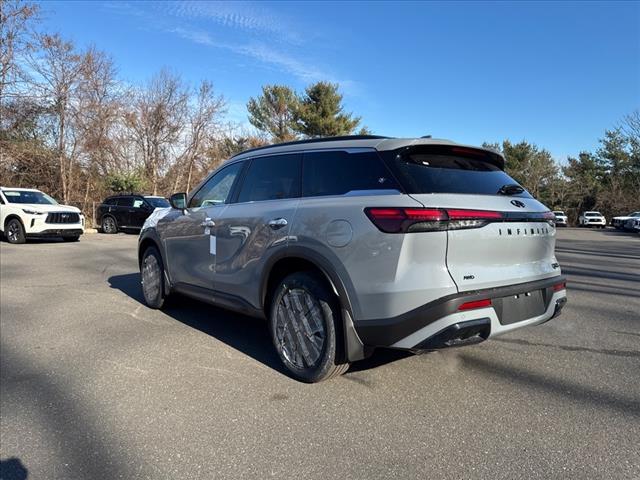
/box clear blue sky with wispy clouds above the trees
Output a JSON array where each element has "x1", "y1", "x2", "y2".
[{"x1": 41, "y1": 1, "x2": 640, "y2": 160}]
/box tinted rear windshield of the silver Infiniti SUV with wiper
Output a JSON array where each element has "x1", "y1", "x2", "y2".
[{"x1": 384, "y1": 145, "x2": 531, "y2": 198}]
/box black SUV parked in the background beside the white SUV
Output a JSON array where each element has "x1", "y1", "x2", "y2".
[{"x1": 96, "y1": 194, "x2": 170, "y2": 233}]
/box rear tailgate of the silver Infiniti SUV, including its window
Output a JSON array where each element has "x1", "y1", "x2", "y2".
[{"x1": 383, "y1": 144, "x2": 560, "y2": 292}]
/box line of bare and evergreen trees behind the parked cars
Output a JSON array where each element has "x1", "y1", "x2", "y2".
[{"x1": 0, "y1": 0, "x2": 640, "y2": 225}]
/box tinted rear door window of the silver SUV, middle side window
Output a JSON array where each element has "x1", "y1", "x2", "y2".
[{"x1": 238, "y1": 154, "x2": 301, "y2": 202}]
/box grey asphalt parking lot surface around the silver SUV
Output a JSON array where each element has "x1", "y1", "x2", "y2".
[{"x1": 0, "y1": 229, "x2": 640, "y2": 480}]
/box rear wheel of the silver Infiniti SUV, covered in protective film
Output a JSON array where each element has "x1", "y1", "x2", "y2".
[{"x1": 269, "y1": 272, "x2": 349, "y2": 383}]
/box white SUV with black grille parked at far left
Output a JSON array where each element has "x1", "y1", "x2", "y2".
[{"x1": 0, "y1": 187, "x2": 84, "y2": 243}]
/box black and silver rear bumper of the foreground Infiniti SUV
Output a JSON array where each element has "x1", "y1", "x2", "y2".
[{"x1": 354, "y1": 275, "x2": 567, "y2": 350}]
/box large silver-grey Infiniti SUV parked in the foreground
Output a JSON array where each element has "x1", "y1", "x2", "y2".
[{"x1": 138, "y1": 136, "x2": 566, "y2": 382}]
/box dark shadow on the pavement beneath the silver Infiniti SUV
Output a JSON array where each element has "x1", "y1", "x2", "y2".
[{"x1": 108, "y1": 273, "x2": 404, "y2": 376}]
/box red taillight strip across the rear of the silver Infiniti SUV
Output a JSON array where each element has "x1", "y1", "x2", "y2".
[{"x1": 364, "y1": 207, "x2": 504, "y2": 233}]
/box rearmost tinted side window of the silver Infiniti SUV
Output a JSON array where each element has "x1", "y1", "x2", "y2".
[{"x1": 302, "y1": 151, "x2": 399, "y2": 197}]
